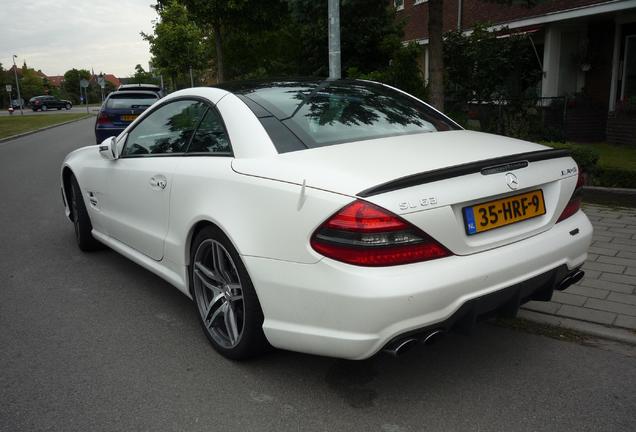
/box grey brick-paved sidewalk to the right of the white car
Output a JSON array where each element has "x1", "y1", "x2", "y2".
[{"x1": 523, "y1": 204, "x2": 636, "y2": 330}]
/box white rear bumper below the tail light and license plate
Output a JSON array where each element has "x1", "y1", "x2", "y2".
[{"x1": 244, "y1": 212, "x2": 592, "y2": 359}]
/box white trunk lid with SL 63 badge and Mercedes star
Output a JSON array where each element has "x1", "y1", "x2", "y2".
[{"x1": 232, "y1": 130, "x2": 576, "y2": 254}]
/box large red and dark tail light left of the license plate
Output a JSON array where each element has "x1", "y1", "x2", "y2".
[{"x1": 311, "y1": 200, "x2": 452, "y2": 267}]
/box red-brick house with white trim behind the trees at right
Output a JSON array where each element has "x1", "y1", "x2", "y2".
[{"x1": 392, "y1": 0, "x2": 636, "y2": 144}]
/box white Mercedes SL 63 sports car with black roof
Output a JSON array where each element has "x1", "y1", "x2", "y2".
[{"x1": 61, "y1": 80, "x2": 592, "y2": 359}]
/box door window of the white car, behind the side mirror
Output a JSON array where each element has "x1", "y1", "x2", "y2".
[{"x1": 122, "y1": 100, "x2": 206, "y2": 157}]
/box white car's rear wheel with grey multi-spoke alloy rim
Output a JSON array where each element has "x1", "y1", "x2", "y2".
[{"x1": 188, "y1": 226, "x2": 269, "y2": 360}]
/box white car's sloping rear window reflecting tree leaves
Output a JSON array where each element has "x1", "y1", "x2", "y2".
[{"x1": 237, "y1": 81, "x2": 458, "y2": 153}]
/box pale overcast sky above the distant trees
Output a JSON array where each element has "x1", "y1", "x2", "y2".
[{"x1": 0, "y1": 0, "x2": 157, "y2": 77}]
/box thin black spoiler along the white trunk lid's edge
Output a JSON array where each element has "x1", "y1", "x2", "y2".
[{"x1": 357, "y1": 149, "x2": 570, "y2": 198}]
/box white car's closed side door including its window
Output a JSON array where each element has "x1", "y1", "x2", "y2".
[{"x1": 101, "y1": 99, "x2": 207, "y2": 260}]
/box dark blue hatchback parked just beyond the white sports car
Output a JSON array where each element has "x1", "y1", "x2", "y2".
[{"x1": 95, "y1": 91, "x2": 159, "y2": 144}]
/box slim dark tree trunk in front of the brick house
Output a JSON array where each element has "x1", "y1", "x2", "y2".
[{"x1": 428, "y1": 0, "x2": 444, "y2": 111}]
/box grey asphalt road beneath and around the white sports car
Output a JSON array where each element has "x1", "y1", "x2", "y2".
[{"x1": 0, "y1": 119, "x2": 636, "y2": 432}]
